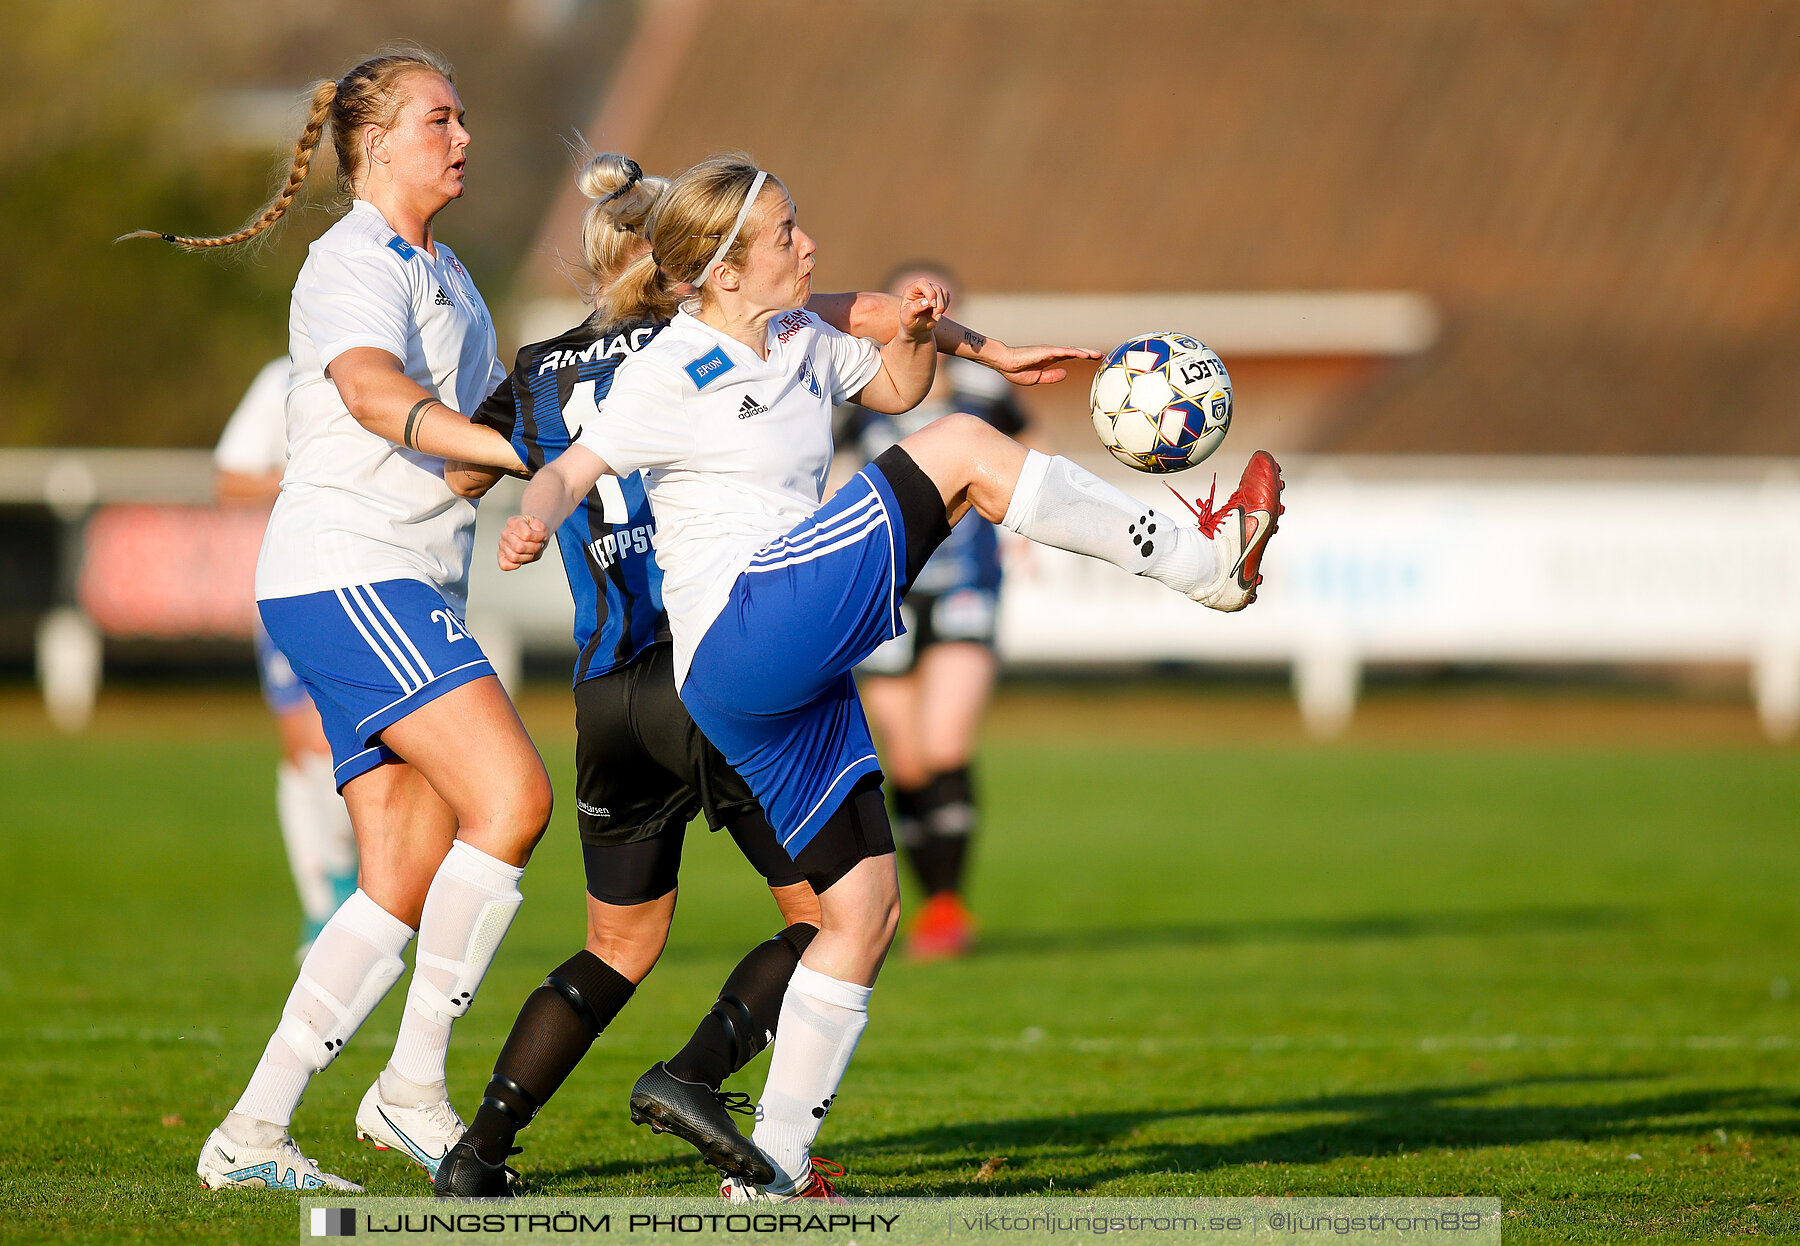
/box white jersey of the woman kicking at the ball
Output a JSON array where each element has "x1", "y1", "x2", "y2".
[{"x1": 571, "y1": 312, "x2": 880, "y2": 684}]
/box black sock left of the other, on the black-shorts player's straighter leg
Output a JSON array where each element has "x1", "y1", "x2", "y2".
[{"x1": 463, "y1": 947, "x2": 637, "y2": 1163}]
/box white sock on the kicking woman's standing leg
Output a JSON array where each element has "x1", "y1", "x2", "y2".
[{"x1": 752, "y1": 965, "x2": 873, "y2": 1185}]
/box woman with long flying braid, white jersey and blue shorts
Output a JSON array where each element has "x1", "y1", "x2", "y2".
[{"x1": 126, "y1": 50, "x2": 551, "y2": 1192}]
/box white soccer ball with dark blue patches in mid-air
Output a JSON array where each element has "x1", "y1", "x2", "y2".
[{"x1": 1089, "y1": 333, "x2": 1231, "y2": 472}]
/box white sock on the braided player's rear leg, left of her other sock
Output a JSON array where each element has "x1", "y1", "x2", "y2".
[{"x1": 227, "y1": 891, "x2": 412, "y2": 1145}]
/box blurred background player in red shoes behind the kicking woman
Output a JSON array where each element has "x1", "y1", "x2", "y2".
[{"x1": 837, "y1": 263, "x2": 1026, "y2": 960}]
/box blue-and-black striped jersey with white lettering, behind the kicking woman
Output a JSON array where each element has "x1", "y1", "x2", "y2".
[{"x1": 472, "y1": 313, "x2": 670, "y2": 684}]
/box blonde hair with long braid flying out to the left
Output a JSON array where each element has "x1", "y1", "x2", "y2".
[{"x1": 113, "y1": 47, "x2": 455, "y2": 250}]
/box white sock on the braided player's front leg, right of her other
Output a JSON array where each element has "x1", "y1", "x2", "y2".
[{"x1": 389, "y1": 839, "x2": 526, "y2": 1106}]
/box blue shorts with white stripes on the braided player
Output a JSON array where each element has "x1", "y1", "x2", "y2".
[{"x1": 257, "y1": 580, "x2": 493, "y2": 789}]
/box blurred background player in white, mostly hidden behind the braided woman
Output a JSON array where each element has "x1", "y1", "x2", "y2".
[{"x1": 212, "y1": 355, "x2": 356, "y2": 960}]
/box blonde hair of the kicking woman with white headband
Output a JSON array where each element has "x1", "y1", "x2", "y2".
[{"x1": 599, "y1": 153, "x2": 785, "y2": 322}]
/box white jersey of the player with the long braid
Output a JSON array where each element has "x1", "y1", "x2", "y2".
[{"x1": 256, "y1": 200, "x2": 506, "y2": 612}]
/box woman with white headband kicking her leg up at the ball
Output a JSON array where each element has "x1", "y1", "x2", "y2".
[{"x1": 500, "y1": 157, "x2": 1282, "y2": 1201}]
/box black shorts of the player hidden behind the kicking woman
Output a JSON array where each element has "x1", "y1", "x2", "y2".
[{"x1": 574, "y1": 641, "x2": 803, "y2": 904}]
